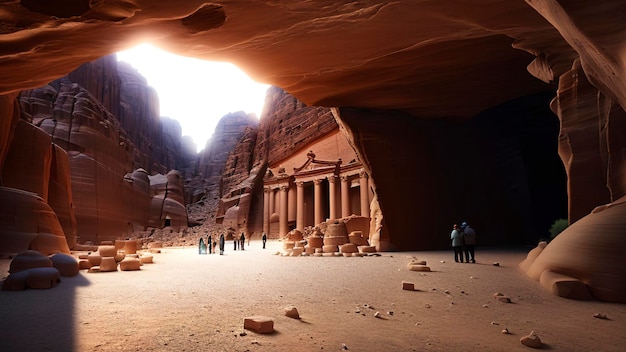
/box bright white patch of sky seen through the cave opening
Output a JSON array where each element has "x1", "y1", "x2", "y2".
[{"x1": 117, "y1": 44, "x2": 269, "y2": 151}]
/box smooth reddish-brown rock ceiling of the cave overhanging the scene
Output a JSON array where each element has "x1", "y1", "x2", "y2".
[{"x1": 0, "y1": 0, "x2": 626, "y2": 118}]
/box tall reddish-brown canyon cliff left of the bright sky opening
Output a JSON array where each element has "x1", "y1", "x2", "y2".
[{"x1": 2, "y1": 55, "x2": 187, "y2": 249}]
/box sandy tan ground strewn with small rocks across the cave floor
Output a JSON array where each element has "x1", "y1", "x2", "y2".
[{"x1": 0, "y1": 241, "x2": 626, "y2": 351}]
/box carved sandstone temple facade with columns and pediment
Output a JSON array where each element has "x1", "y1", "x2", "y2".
[{"x1": 263, "y1": 130, "x2": 373, "y2": 238}]
